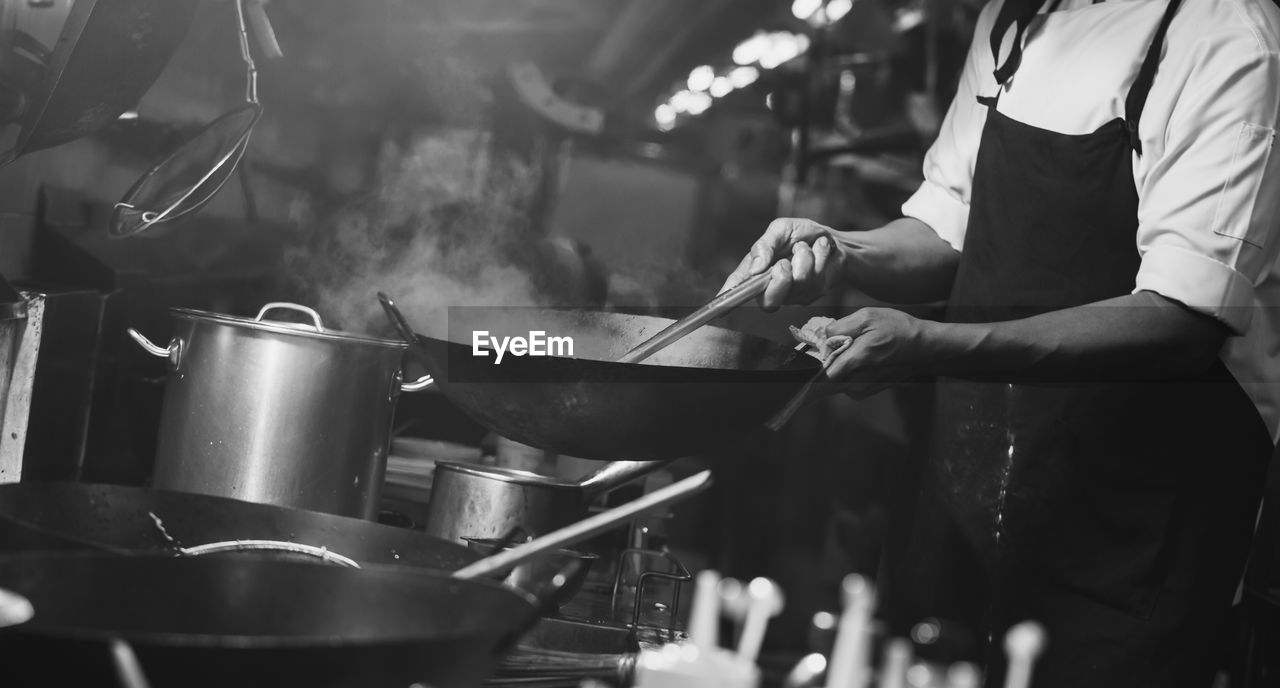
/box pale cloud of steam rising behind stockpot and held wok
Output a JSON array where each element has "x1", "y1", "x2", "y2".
[{"x1": 285, "y1": 125, "x2": 728, "y2": 338}]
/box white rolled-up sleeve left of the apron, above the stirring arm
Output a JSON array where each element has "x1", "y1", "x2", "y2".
[{"x1": 902, "y1": 1, "x2": 1001, "y2": 251}]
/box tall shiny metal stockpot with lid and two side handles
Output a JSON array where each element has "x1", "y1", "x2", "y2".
[{"x1": 129, "y1": 303, "x2": 430, "y2": 519}]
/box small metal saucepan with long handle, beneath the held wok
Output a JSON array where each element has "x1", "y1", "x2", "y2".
[{"x1": 425, "y1": 462, "x2": 671, "y2": 542}]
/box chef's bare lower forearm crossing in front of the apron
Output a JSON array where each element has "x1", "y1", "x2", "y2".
[{"x1": 922, "y1": 286, "x2": 1230, "y2": 381}]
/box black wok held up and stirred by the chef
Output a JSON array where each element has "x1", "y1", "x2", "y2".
[{"x1": 419, "y1": 308, "x2": 818, "y2": 460}]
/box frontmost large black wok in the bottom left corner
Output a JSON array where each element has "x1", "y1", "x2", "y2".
[{"x1": 0, "y1": 552, "x2": 538, "y2": 688}]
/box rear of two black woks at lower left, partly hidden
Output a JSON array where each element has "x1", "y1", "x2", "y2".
[{"x1": 0, "y1": 482, "x2": 480, "y2": 570}]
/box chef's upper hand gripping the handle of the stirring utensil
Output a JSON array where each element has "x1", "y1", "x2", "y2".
[{"x1": 721, "y1": 217, "x2": 845, "y2": 311}]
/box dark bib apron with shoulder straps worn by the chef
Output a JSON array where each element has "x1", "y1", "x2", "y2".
[{"x1": 908, "y1": 0, "x2": 1272, "y2": 688}]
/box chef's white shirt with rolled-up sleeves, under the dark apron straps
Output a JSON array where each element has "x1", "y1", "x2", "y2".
[{"x1": 902, "y1": 0, "x2": 1280, "y2": 439}]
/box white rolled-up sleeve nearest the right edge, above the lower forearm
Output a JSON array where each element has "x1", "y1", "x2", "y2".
[{"x1": 1134, "y1": 32, "x2": 1280, "y2": 334}]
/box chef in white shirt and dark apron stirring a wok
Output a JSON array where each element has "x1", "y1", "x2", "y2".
[{"x1": 726, "y1": 0, "x2": 1280, "y2": 688}]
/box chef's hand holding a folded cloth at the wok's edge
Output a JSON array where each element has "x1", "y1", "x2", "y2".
[{"x1": 824, "y1": 308, "x2": 931, "y2": 398}]
